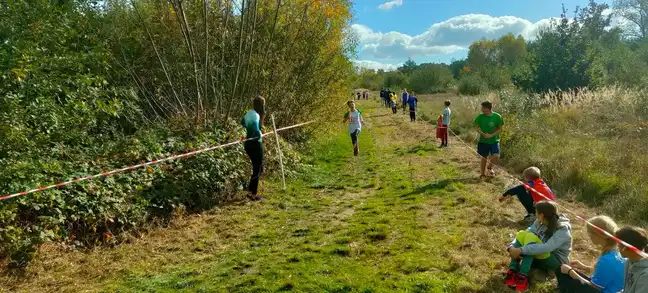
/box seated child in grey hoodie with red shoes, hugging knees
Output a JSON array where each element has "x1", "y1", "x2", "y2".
[{"x1": 505, "y1": 201, "x2": 572, "y2": 292}]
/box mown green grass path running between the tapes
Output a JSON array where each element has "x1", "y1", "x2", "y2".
[{"x1": 0, "y1": 97, "x2": 596, "y2": 292}]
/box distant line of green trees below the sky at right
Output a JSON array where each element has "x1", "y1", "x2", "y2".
[{"x1": 355, "y1": 0, "x2": 648, "y2": 95}]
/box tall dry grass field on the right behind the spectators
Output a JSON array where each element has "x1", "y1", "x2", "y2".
[{"x1": 421, "y1": 88, "x2": 648, "y2": 225}]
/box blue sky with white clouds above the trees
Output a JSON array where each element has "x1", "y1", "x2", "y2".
[{"x1": 352, "y1": 0, "x2": 612, "y2": 69}]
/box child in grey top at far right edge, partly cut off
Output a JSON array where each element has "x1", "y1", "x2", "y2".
[{"x1": 615, "y1": 227, "x2": 648, "y2": 293}]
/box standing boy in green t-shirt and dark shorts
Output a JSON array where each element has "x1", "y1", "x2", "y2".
[{"x1": 474, "y1": 101, "x2": 504, "y2": 178}]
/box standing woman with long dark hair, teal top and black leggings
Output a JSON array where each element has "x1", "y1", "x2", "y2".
[{"x1": 241, "y1": 96, "x2": 265, "y2": 201}]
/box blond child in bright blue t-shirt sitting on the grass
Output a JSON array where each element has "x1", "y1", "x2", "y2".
[{"x1": 560, "y1": 216, "x2": 626, "y2": 293}]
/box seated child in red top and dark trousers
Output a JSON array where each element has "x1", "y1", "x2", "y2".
[{"x1": 499, "y1": 167, "x2": 554, "y2": 223}]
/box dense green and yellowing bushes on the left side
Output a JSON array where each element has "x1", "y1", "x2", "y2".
[{"x1": 0, "y1": 0, "x2": 353, "y2": 265}]
